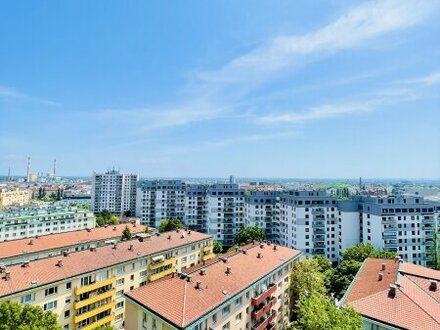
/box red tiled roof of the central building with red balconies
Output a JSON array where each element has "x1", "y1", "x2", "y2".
[{"x1": 127, "y1": 245, "x2": 301, "y2": 327}]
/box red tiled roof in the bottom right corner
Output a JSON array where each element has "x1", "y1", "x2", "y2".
[{"x1": 343, "y1": 258, "x2": 440, "y2": 330}]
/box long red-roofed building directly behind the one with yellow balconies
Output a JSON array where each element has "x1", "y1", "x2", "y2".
[{"x1": 0, "y1": 224, "x2": 146, "y2": 266}]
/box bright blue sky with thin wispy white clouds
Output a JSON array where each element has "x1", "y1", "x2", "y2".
[{"x1": 0, "y1": 0, "x2": 440, "y2": 178}]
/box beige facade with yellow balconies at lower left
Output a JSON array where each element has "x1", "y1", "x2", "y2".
[{"x1": 0, "y1": 232, "x2": 213, "y2": 330}]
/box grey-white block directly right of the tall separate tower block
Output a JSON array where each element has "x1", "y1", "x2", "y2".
[{"x1": 136, "y1": 180, "x2": 186, "y2": 227}]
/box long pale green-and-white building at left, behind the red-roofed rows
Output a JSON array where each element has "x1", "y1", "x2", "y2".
[{"x1": 0, "y1": 206, "x2": 96, "y2": 242}]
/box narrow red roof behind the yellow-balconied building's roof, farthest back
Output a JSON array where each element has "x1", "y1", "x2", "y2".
[{"x1": 0, "y1": 224, "x2": 146, "y2": 261}]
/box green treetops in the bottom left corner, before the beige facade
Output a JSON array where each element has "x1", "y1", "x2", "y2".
[{"x1": 0, "y1": 302, "x2": 61, "y2": 330}]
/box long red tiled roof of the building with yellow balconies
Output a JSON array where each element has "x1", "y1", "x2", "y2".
[{"x1": 0, "y1": 231, "x2": 211, "y2": 298}]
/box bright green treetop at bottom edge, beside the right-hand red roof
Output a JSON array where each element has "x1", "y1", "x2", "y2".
[{"x1": 290, "y1": 292, "x2": 362, "y2": 330}]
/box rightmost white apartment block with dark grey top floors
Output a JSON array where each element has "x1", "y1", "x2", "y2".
[{"x1": 360, "y1": 196, "x2": 440, "y2": 266}]
